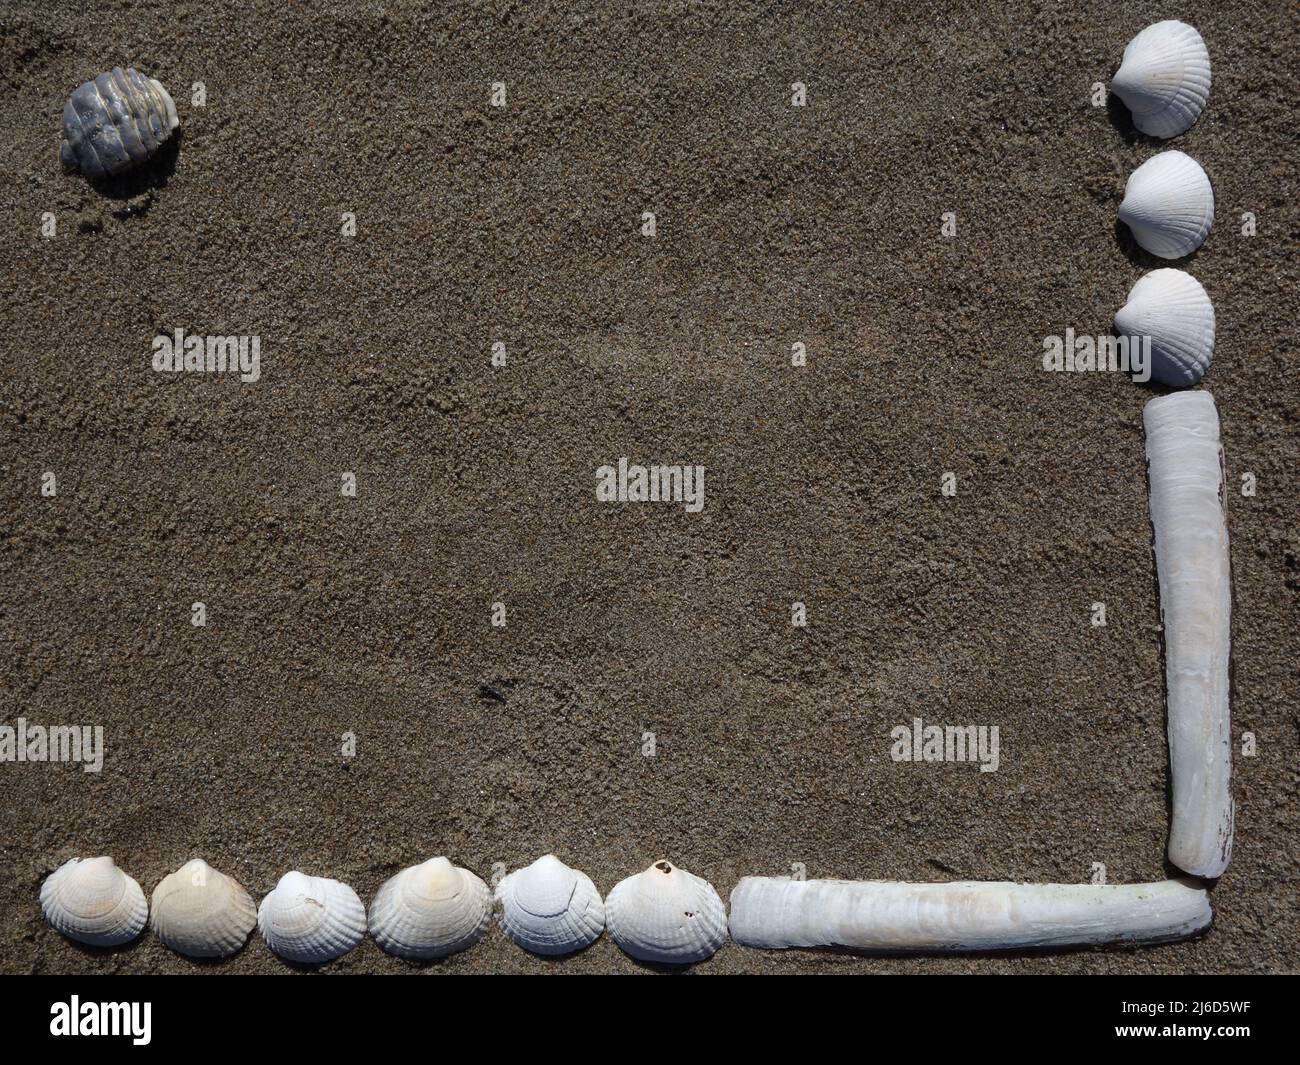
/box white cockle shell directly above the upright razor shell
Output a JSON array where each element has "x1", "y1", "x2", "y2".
[{"x1": 1115, "y1": 269, "x2": 1214, "y2": 386}]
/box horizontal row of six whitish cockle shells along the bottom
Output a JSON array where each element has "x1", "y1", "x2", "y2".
[{"x1": 40, "y1": 854, "x2": 727, "y2": 965}]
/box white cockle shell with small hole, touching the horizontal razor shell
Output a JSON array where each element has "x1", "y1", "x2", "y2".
[{"x1": 605, "y1": 861, "x2": 727, "y2": 965}]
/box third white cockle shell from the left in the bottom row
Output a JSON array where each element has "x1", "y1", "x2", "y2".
[{"x1": 257, "y1": 870, "x2": 365, "y2": 965}]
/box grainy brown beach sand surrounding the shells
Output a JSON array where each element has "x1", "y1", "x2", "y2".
[{"x1": 0, "y1": 0, "x2": 1300, "y2": 974}]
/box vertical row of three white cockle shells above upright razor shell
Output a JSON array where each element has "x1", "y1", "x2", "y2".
[{"x1": 1110, "y1": 20, "x2": 1214, "y2": 388}]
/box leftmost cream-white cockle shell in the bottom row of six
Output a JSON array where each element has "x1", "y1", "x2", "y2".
[{"x1": 40, "y1": 856, "x2": 150, "y2": 947}]
